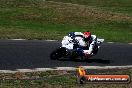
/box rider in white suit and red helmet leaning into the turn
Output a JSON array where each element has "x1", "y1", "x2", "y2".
[{"x1": 69, "y1": 31, "x2": 97, "y2": 57}]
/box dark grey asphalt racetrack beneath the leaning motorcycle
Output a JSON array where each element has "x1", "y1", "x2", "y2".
[{"x1": 0, "y1": 40, "x2": 132, "y2": 70}]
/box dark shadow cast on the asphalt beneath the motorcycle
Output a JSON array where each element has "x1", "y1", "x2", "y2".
[{"x1": 59, "y1": 58, "x2": 111, "y2": 64}]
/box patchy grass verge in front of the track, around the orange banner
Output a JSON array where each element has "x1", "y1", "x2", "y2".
[{"x1": 0, "y1": 69, "x2": 132, "y2": 88}]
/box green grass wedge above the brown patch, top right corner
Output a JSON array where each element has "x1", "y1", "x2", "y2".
[{"x1": 48, "y1": 0, "x2": 132, "y2": 15}]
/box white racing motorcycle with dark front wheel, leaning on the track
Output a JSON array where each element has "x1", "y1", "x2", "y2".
[{"x1": 50, "y1": 36, "x2": 104, "y2": 60}]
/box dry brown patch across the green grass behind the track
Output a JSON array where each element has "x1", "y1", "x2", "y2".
[{"x1": 43, "y1": 1, "x2": 132, "y2": 25}]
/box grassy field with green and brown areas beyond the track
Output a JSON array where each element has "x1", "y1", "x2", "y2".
[{"x1": 0, "y1": 0, "x2": 132, "y2": 42}]
